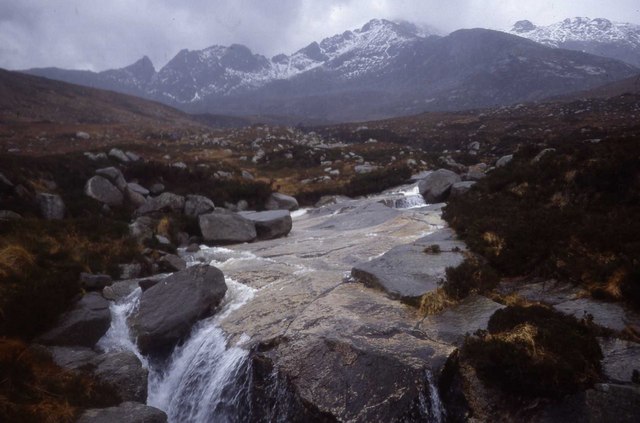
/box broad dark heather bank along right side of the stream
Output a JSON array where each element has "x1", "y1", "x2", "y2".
[{"x1": 444, "y1": 137, "x2": 640, "y2": 308}]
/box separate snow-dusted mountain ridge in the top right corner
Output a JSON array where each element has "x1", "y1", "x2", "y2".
[{"x1": 510, "y1": 17, "x2": 640, "y2": 66}]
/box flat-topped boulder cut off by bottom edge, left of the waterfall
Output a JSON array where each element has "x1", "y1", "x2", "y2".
[{"x1": 78, "y1": 402, "x2": 167, "y2": 423}]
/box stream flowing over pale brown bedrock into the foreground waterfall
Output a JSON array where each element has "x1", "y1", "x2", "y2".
[{"x1": 99, "y1": 187, "x2": 451, "y2": 423}]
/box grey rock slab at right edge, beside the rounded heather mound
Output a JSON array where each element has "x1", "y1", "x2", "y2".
[{"x1": 598, "y1": 338, "x2": 640, "y2": 383}]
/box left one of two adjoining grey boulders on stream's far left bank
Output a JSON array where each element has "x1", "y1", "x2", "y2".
[{"x1": 198, "y1": 210, "x2": 258, "y2": 244}]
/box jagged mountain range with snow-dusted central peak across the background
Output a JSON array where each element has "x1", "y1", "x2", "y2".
[{"x1": 26, "y1": 19, "x2": 640, "y2": 121}]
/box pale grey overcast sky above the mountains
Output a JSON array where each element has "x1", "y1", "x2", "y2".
[{"x1": 0, "y1": 0, "x2": 640, "y2": 71}]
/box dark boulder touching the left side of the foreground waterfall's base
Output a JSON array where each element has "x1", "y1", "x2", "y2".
[{"x1": 90, "y1": 351, "x2": 149, "y2": 403}]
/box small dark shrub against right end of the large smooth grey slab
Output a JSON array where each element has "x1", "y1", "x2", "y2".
[{"x1": 443, "y1": 258, "x2": 500, "y2": 299}]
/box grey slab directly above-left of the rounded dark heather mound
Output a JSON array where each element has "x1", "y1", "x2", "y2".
[{"x1": 419, "y1": 295, "x2": 504, "y2": 346}]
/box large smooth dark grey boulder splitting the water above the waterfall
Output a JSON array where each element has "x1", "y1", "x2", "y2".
[{"x1": 131, "y1": 265, "x2": 227, "y2": 354}]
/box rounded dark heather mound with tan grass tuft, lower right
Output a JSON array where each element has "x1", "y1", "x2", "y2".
[{"x1": 461, "y1": 306, "x2": 602, "y2": 398}]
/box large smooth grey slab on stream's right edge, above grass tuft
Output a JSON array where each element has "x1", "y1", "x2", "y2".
[{"x1": 351, "y1": 230, "x2": 466, "y2": 302}]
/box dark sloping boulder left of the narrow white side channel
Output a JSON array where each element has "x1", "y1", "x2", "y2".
[{"x1": 39, "y1": 292, "x2": 111, "y2": 347}]
